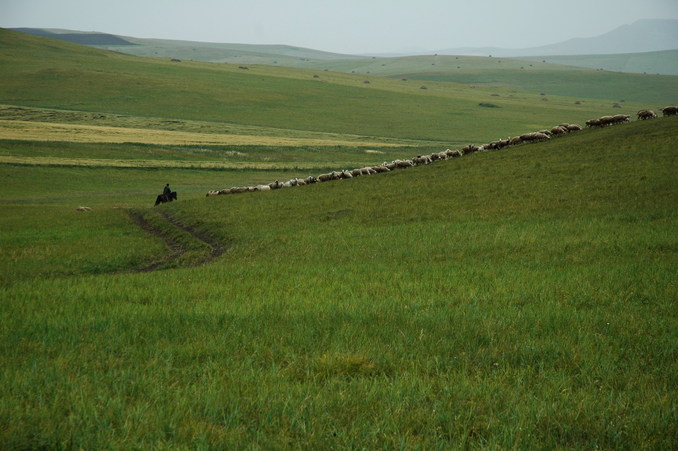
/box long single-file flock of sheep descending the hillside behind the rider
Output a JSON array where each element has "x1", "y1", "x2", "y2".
[{"x1": 207, "y1": 106, "x2": 678, "y2": 197}]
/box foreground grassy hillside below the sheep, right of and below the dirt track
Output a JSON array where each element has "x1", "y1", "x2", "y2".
[{"x1": 0, "y1": 120, "x2": 678, "y2": 449}]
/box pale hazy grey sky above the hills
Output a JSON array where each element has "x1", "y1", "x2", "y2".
[{"x1": 0, "y1": 0, "x2": 678, "y2": 53}]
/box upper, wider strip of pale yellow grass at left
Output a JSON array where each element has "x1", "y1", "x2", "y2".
[{"x1": 0, "y1": 120, "x2": 398, "y2": 147}]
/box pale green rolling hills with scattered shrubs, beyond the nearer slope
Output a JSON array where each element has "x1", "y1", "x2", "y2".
[{"x1": 13, "y1": 29, "x2": 678, "y2": 102}]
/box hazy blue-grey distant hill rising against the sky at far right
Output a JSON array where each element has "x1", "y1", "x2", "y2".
[{"x1": 436, "y1": 19, "x2": 678, "y2": 57}]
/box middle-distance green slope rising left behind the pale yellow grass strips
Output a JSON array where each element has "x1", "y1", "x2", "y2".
[{"x1": 0, "y1": 30, "x2": 673, "y2": 144}]
